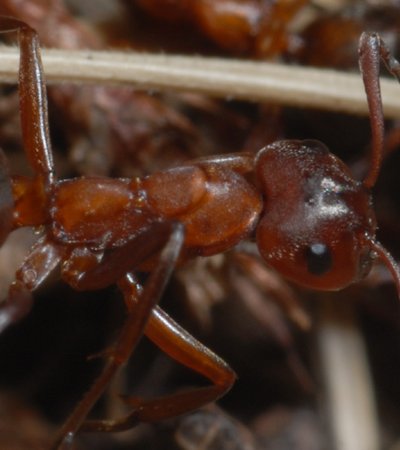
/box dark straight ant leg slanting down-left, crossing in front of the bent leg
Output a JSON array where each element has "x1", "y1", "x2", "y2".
[{"x1": 53, "y1": 223, "x2": 184, "y2": 449}]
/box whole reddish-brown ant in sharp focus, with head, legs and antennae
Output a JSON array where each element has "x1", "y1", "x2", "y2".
[{"x1": 0, "y1": 17, "x2": 400, "y2": 448}]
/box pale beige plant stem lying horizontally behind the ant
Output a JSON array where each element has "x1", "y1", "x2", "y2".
[{"x1": 0, "y1": 47, "x2": 400, "y2": 118}]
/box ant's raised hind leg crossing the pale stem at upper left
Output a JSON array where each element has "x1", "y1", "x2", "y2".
[{"x1": 0, "y1": 17, "x2": 54, "y2": 189}]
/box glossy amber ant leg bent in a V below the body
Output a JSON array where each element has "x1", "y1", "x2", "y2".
[{"x1": 82, "y1": 307, "x2": 236, "y2": 432}]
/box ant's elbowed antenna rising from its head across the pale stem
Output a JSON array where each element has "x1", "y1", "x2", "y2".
[{"x1": 358, "y1": 32, "x2": 400, "y2": 189}]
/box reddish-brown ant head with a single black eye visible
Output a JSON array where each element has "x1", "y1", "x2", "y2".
[{"x1": 256, "y1": 140, "x2": 376, "y2": 290}]
